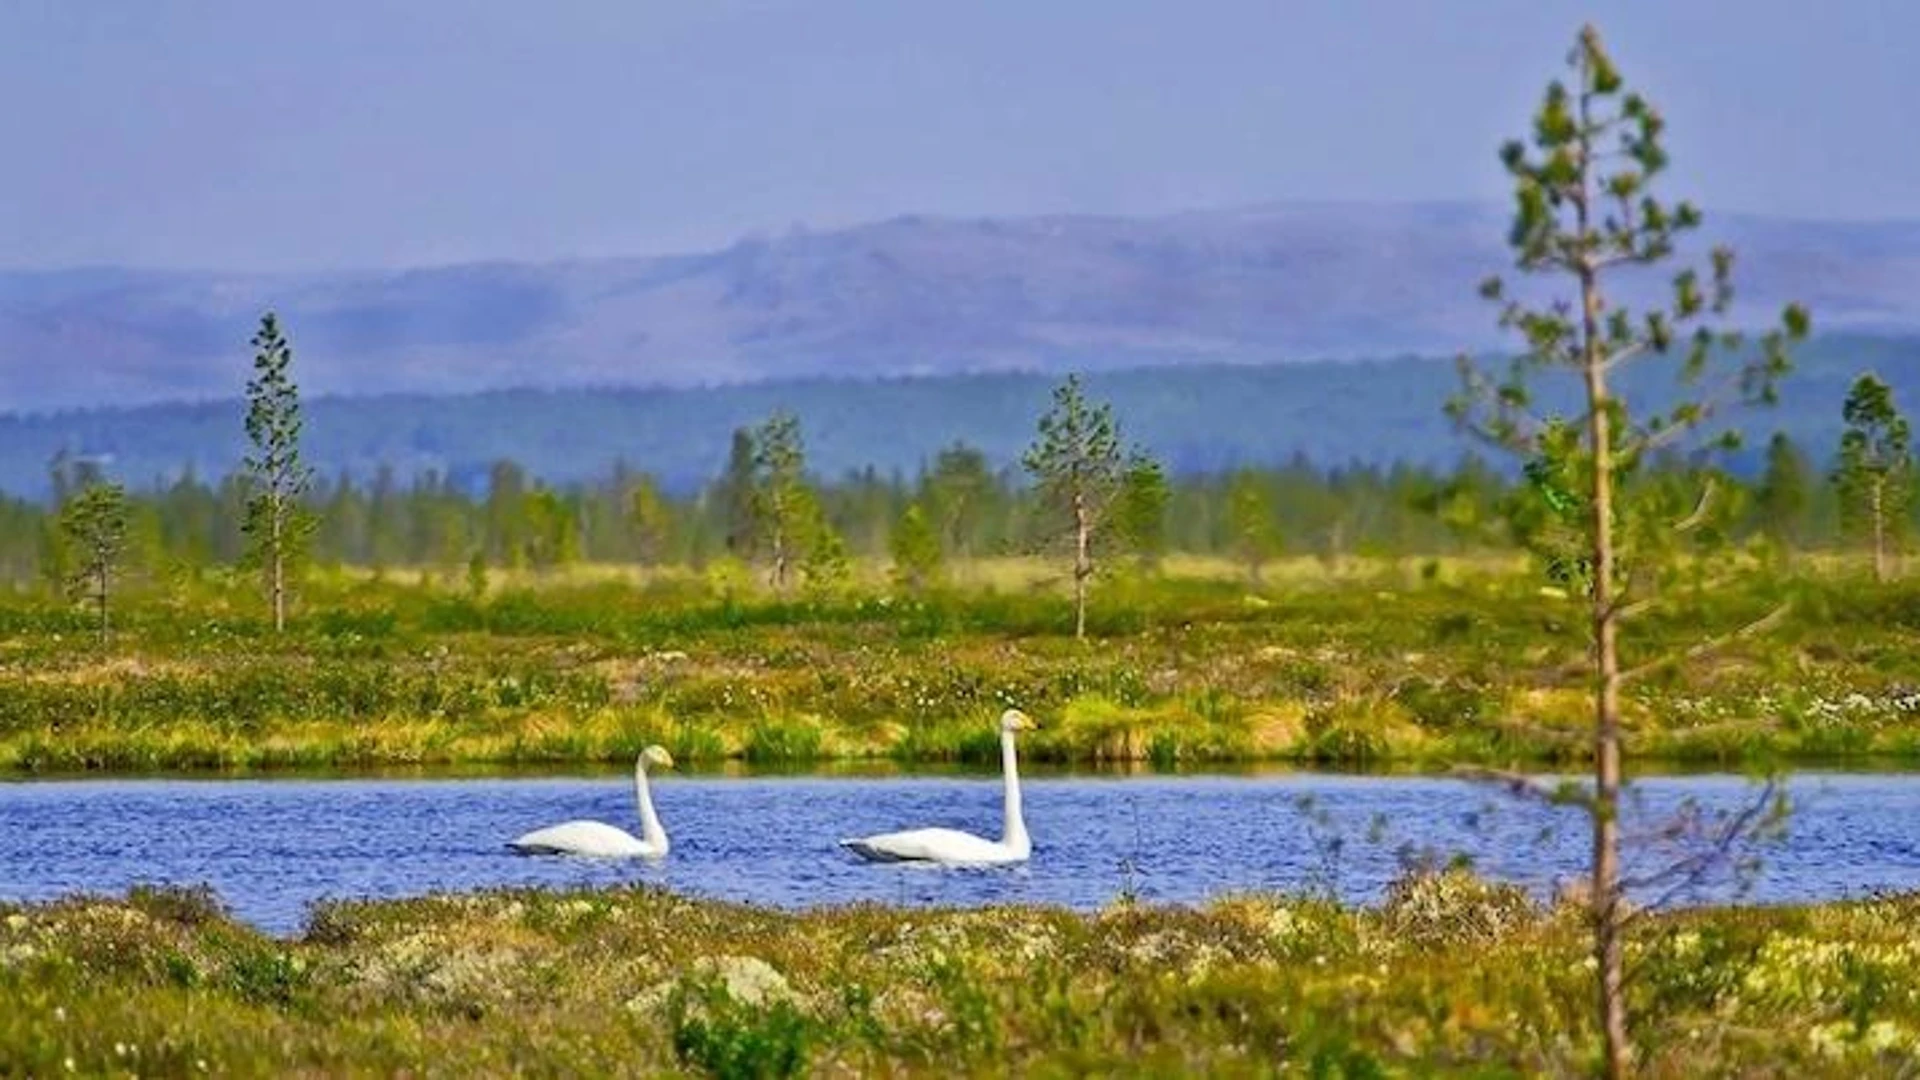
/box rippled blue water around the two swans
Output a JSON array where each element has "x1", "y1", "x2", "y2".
[{"x1": 0, "y1": 774, "x2": 1920, "y2": 934}]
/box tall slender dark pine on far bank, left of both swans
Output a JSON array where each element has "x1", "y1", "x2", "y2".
[{"x1": 242, "y1": 311, "x2": 315, "y2": 632}]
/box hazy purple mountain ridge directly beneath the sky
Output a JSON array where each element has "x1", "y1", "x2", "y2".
[{"x1": 0, "y1": 204, "x2": 1920, "y2": 413}]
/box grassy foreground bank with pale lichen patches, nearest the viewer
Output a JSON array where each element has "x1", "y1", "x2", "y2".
[{"x1": 0, "y1": 872, "x2": 1920, "y2": 1076}]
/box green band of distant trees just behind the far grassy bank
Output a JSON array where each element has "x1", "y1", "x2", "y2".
[{"x1": 0, "y1": 418, "x2": 1889, "y2": 588}]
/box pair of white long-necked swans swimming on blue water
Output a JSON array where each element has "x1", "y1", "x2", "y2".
[{"x1": 509, "y1": 709, "x2": 1037, "y2": 867}]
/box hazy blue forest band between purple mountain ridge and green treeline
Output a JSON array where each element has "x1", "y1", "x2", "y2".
[{"x1": 0, "y1": 334, "x2": 1920, "y2": 500}]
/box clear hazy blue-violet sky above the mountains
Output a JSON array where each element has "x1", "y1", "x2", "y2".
[{"x1": 0, "y1": 0, "x2": 1920, "y2": 271}]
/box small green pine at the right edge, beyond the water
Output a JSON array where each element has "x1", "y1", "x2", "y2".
[{"x1": 1834, "y1": 375, "x2": 1914, "y2": 580}]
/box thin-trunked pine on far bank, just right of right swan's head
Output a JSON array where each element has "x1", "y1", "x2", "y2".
[{"x1": 1021, "y1": 375, "x2": 1123, "y2": 638}]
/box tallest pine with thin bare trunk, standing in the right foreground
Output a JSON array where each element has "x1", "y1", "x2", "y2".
[{"x1": 1448, "y1": 27, "x2": 1807, "y2": 1076}]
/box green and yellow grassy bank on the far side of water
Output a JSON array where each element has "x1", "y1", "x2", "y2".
[{"x1": 0, "y1": 561, "x2": 1920, "y2": 773}]
